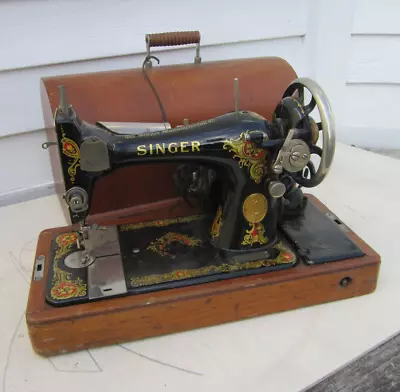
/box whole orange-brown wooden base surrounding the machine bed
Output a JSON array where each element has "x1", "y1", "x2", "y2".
[{"x1": 26, "y1": 196, "x2": 380, "y2": 356}]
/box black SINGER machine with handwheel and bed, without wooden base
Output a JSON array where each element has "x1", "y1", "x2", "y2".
[{"x1": 46, "y1": 80, "x2": 363, "y2": 306}]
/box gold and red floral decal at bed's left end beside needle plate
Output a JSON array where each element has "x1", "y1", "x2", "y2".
[{"x1": 50, "y1": 233, "x2": 86, "y2": 299}]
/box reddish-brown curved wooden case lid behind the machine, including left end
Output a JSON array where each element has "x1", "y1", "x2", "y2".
[{"x1": 41, "y1": 57, "x2": 296, "y2": 220}]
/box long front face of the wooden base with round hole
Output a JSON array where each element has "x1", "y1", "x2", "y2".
[{"x1": 27, "y1": 265, "x2": 379, "y2": 356}]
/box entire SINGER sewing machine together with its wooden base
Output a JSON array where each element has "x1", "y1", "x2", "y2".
[{"x1": 27, "y1": 34, "x2": 380, "y2": 355}]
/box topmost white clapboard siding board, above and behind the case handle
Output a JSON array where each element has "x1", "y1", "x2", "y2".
[{"x1": 0, "y1": 0, "x2": 307, "y2": 70}]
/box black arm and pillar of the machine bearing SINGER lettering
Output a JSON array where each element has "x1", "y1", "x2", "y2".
[{"x1": 56, "y1": 112, "x2": 282, "y2": 251}]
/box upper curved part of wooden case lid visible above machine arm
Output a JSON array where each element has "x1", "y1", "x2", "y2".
[{"x1": 42, "y1": 57, "x2": 296, "y2": 128}]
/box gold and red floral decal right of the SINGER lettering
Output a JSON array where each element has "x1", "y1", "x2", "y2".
[{"x1": 224, "y1": 131, "x2": 267, "y2": 184}]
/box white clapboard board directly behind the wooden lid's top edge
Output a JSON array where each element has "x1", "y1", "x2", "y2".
[{"x1": 0, "y1": 37, "x2": 306, "y2": 136}]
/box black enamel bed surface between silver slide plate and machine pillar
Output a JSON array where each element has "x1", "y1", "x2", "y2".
[{"x1": 119, "y1": 217, "x2": 296, "y2": 294}]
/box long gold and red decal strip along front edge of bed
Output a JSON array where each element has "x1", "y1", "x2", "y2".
[{"x1": 130, "y1": 243, "x2": 296, "y2": 287}]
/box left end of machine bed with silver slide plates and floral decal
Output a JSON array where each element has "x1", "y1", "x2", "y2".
[{"x1": 49, "y1": 225, "x2": 127, "y2": 304}]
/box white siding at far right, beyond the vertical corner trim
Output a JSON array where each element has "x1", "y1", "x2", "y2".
[{"x1": 340, "y1": 0, "x2": 400, "y2": 148}]
